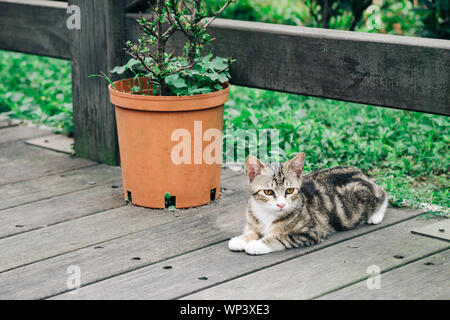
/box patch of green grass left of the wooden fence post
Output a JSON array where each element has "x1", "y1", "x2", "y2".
[{"x1": 0, "y1": 50, "x2": 73, "y2": 133}]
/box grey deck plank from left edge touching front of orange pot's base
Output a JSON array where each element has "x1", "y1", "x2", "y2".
[{"x1": 0, "y1": 172, "x2": 246, "y2": 272}]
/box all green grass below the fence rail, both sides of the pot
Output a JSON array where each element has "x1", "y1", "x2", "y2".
[{"x1": 0, "y1": 51, "x2": 450, "y2": 215}]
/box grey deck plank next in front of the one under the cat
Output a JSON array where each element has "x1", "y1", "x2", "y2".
[{"x1": 186, "y1": 219, "x2": 450, "y2": 300}]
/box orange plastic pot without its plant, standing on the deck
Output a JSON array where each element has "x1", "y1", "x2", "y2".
[{"x1": 109, "y1": 79, "x2": 229, "y2": 208}]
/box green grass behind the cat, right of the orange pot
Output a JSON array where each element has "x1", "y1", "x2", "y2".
[{"x1": 225, "y1": 86, "x2": 450, "y2": 207}]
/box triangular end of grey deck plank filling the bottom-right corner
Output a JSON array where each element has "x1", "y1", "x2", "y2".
[{"x1": 321, "y1": 250, "x2": 450, "y2": 300}]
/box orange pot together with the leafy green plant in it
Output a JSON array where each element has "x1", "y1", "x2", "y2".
[{"x1": 105, "y1": 0, "x2": 233, "y2": 208}]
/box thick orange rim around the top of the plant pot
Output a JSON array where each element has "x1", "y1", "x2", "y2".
[{"x1": 108, "y1": 78, "x2": 230, "y2": 111}]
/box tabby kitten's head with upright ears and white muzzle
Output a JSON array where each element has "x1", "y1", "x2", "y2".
[{"x1": 245, "y1": 153, "x2": 305, "y2": 215}]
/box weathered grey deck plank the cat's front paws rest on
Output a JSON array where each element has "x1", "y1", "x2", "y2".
[{"x1": 51, "y1": 209, "x2": 424, "y2": 299}]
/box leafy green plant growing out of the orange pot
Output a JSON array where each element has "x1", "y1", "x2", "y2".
[{"x1": 113, "y1": 0, "x2": 236, "y2": 96}]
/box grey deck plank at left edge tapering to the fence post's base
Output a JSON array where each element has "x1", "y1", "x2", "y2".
[{"x1": 0, "y1": 142, "x2": 96, "y2": 185}]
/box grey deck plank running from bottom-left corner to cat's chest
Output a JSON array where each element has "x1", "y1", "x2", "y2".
[{"x1": 0, "y1": 176, "x2": 248, "y2": 299}]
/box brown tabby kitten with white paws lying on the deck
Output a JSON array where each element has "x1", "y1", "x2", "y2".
[{"x1": 228, "y1": 153, "x2": 388, "y2": 255}]
